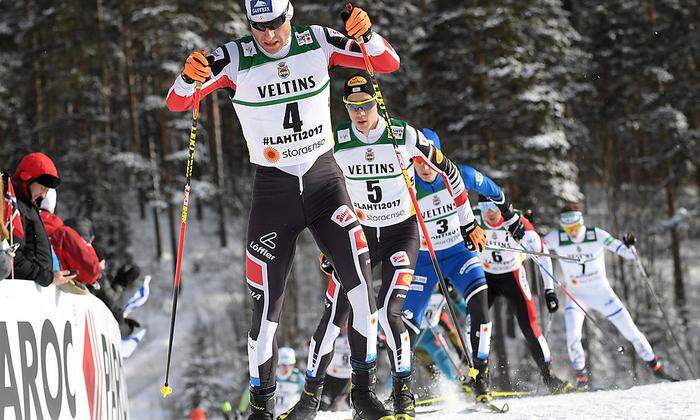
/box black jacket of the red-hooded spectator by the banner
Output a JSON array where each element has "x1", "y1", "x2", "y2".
[{"x1": 14, "y1": 182, "x2": 53, "y2": 286}]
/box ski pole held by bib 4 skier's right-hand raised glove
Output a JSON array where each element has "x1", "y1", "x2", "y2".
[{"x1": 343, "y1": 3, "x2": 478, "y2": 378}]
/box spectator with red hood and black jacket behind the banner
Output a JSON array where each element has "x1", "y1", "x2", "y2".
[{"x1": 12, "y1": 153, "x2": 75, "y2": 286}]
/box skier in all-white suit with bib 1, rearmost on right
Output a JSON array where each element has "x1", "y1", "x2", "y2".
[{"x1": 544, "y1": 204, "x2": 675, "y2": 389}]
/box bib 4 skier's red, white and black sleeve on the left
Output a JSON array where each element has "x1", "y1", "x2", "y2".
[{"x1": 165, "y1": 42, "x2": 238, "y2": 112}]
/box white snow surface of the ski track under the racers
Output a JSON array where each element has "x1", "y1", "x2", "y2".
[{"x1": 316, "y1": 380, "x2": 700, "y2": 420}]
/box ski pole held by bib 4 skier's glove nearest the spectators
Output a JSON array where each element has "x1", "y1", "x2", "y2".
[{"x1": 160, "y1": 82, "x2": 202, "y2": 398}]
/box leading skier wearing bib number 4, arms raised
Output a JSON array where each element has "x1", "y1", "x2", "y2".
[{"x1": 166, "y1": 0, "x2": 399, "y2": 419}]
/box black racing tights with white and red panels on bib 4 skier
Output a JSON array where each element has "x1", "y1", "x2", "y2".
[{"x1": 246, "y1": 151, "x2": 378, "y2": 393}]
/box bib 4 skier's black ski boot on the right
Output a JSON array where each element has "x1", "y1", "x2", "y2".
[{"x1": 350, "y1": 364, "x2": 394, "y2": 420}]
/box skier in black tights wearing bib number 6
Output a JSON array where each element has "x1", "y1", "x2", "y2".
[{"x1": 474, "y1": 196, "x2": 572, "y2": 394}]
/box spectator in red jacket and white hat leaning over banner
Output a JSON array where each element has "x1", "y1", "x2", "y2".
[{"x1": 40, "y1": 189, "x2": 100, "y2": 284}]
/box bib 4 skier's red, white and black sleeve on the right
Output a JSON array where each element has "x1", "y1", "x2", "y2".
[{"x1": 311, "y1": 25, "x2": 401, "y2": 73}]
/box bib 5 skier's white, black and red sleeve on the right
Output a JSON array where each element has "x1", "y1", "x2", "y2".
[{"x1": 408, "y1": 126, "x2": 474, "y2": 226}]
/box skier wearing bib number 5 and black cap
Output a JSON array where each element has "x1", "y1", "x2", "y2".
[{"x1": 287, "y1": 72, "x2": 483, "y2": 419}]
